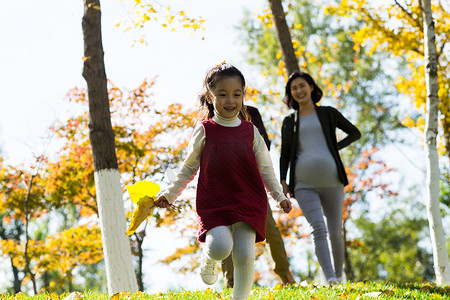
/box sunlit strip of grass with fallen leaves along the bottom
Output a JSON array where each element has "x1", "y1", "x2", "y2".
[{"x1": 0, "y1": 282, "x2": 450, "y2": 300}]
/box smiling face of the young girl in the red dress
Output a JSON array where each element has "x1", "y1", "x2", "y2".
[{"x1": 208, "y1": 76, "x2": 244, "y2": 118}]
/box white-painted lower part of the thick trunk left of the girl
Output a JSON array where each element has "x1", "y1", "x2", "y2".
[{"x1": 94, "y1": 169, "x2": 138, "y2": 294}]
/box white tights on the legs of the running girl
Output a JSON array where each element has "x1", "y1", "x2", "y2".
[{"x1": 203, "y1": 222, "x2": 256, "y2": 300}]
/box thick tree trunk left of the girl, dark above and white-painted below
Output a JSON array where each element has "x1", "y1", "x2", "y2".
[{"x1": 82, "y1": 0, "x2": 137, "y2": 293}]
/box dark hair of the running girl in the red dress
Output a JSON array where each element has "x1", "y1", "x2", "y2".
[{"x1": 197, "y1": 64, "x2": 250, "y2": 121}]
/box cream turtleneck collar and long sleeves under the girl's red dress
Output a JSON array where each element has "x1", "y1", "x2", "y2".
[{"x1": 162, "y1": 113, "x2": 287, "y2": 203}]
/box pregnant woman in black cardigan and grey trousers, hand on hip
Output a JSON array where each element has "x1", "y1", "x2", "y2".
[{"x1": 280, "y1": 72, "x2": 361, "y2": 284}]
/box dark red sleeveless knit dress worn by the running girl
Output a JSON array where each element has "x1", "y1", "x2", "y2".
[{"x1": 196, "y1": 120, "x2": 267, "y2": 242}]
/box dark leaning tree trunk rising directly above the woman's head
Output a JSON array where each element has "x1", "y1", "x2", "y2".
[{"x1": 269, "y1": 0, "x2": 300, "y2": 76}]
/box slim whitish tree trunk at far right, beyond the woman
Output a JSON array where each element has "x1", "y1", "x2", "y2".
[{"x1": 421, "y1": 0, "x2": 450, "y2": 284}]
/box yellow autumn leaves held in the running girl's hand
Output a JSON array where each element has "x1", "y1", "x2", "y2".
[{"x1": 125, "y1": 181, "x2": 160, "y2": 235}]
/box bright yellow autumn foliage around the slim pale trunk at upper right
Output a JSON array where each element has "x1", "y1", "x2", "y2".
[{"x1": 325, "y1": 0, "x2": 450, "y2": 155}]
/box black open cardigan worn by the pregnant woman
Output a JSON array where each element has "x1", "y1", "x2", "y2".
[{"x1": 280, "y1": 106, "x2": 361, "y2": 193}]
